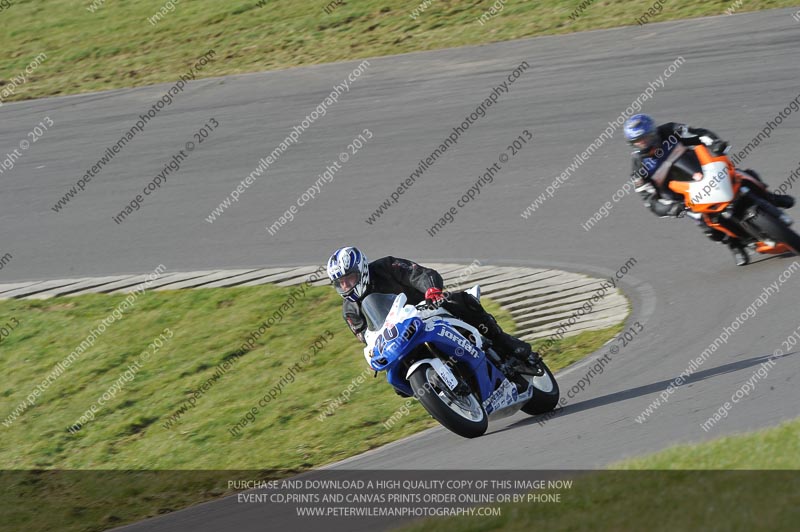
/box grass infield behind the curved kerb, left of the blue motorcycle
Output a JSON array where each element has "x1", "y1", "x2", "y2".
[{"x1": 0, "y1": 285, "x2": 612, "y2": 530}]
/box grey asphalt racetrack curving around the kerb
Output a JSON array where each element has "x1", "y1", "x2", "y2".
[{"x1": 0, "y1": 5, "x2": 800, "y2": 530}]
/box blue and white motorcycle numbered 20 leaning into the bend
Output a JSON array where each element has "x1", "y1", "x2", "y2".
[{"x1": 361, "y1": 286, "x2": 559, "y2": 438}]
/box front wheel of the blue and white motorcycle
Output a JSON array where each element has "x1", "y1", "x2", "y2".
[{"x1": 409, "y1": 364, "x2": 489, "y2": 438}]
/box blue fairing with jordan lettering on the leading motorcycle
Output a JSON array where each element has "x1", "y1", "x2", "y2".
[{"x1": 370, "y1": 317, "x2": 506, "y2": 402}]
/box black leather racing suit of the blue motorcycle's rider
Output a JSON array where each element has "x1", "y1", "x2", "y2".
[{"x1": 342, "y1": 257, "x2": 530, "y2": 354}]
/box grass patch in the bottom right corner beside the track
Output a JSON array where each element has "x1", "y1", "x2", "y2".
[{"x1": 402, "y1": 419, "x2": 800, "y2": 532}]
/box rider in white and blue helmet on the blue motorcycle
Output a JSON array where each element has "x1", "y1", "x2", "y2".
[{"x1": 328, "y1": 247, "x2": 539, "y2": 364}]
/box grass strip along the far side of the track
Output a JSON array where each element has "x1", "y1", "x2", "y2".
[{"x1": 0, "y1": 0, "x2": 796, "y2": 101}]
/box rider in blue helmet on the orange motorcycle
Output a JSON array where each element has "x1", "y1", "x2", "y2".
[{"x1": 623, "y1": 114, "x2": 794, "y2": 266}]
